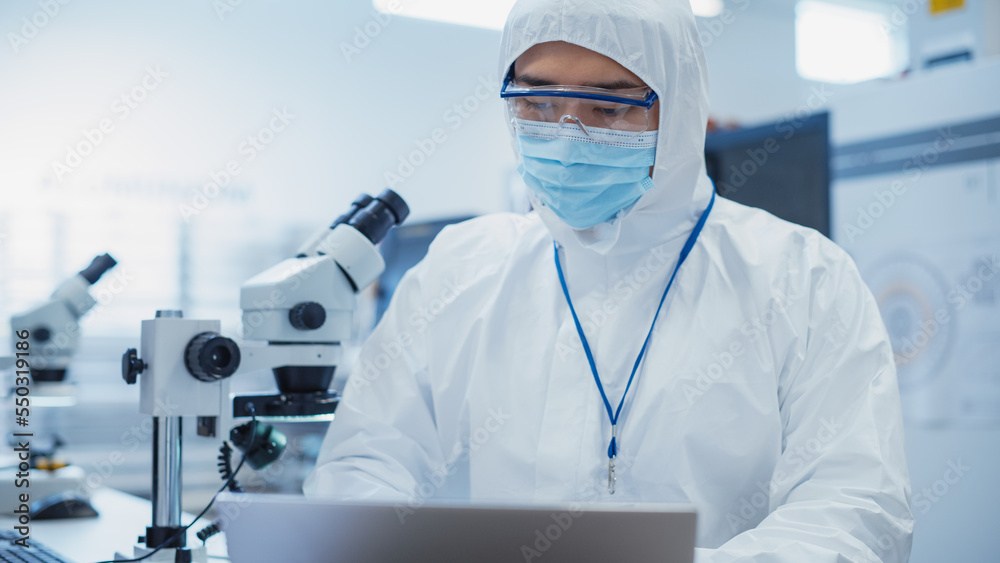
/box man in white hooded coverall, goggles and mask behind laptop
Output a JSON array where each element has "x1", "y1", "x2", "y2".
[{"x1": 305, "y1": 0, "x2": 913, "y2": 563}]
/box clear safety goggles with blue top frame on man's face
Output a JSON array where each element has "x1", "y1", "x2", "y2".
[{"x1": 500, "y1": 68, "x2": 656, "y2": 138}]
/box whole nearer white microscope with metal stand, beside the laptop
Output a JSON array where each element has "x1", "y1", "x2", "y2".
[{"x1": 116, "y1": 189, "x2": 409, "y2": 563}]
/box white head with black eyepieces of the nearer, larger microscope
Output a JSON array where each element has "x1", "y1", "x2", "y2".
[{"x1": 233, "y1": 190, "x2": 409, "y2": 420}]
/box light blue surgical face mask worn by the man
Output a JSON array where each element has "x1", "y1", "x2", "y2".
[{"x1": 517, "y1": 120, "x2": 656, "y2": 229}]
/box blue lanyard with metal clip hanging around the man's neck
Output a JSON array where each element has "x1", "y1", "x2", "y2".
[{"x1": 552, "y1": 190, "x2": 715, "y2": 494}]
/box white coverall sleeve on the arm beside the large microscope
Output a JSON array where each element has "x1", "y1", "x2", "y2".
[{"x1": 303, "y1": 264, "x2": 444, "y2": 501}]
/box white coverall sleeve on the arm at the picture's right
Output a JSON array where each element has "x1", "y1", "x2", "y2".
[{"x1": 695, "y1": 241, "x2": 913, "y2": 563}]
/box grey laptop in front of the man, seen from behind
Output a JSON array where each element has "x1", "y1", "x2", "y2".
[{"x1": 218, "y1": 493, "x2": 696, "y2": 563}]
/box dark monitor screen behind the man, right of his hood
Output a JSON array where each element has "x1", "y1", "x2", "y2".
[{"x1": 705, "y1": 113, "x2": 830, "y2": 236}]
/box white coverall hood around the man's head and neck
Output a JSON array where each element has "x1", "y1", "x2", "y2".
[{"x1": 499, "y1": 0, "x2": 712, "y2": 255}]
